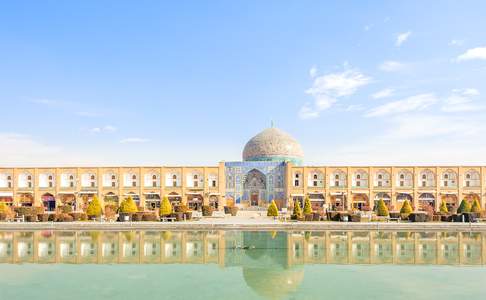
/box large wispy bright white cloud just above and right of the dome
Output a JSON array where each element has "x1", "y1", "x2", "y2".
[{"x1": 299, "y1": 69, "x2": 371, "y2": 119}]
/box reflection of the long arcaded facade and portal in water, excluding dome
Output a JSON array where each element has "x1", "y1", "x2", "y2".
[{"x1": 0, "y1": 231, "x2": 486, "y2": 266}]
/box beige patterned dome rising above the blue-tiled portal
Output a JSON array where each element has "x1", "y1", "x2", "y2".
[{"x1": 243, "y1": 127, "x2": 304, "y2": 164}]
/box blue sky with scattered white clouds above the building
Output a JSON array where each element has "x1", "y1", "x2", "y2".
[{"x1": 0, "y1": 1, "x2": 486, "y2": 165}]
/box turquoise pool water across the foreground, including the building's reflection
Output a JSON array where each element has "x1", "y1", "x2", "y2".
[{"x1": 0, "y1": 231, "x2": 486, "y2": 299}]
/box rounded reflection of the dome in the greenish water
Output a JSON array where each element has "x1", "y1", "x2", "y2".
[{"x1": 243, "y1": 267, "x2": 304, "y2": 299}]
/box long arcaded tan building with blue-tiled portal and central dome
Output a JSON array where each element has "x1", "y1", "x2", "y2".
[{"x1": 0, "y1": 127, "x2": 486, "y2": 210}]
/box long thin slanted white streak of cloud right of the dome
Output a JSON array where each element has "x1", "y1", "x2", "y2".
[{"x1": 365, "y1": 93, "x2": 439, "y2": 117}]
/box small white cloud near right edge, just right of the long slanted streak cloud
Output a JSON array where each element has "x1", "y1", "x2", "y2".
[{"x1": 442, "y1": 88, "x2": 486, "y2": 112}]
